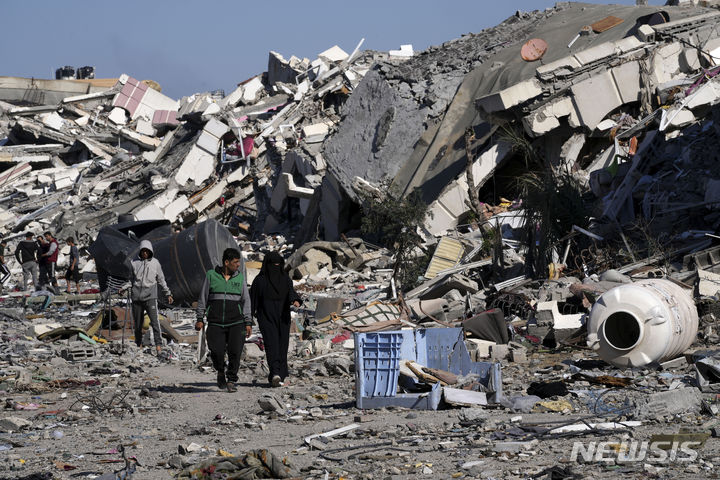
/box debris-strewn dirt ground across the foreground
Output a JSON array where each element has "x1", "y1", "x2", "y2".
[{"x1": 0, "y1": 324, "x2": 720, "y2": 479}]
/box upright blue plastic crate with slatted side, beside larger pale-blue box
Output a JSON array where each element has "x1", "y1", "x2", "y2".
[{"x1": 355, "y1": 332, "x2": 403, "y2": 397}]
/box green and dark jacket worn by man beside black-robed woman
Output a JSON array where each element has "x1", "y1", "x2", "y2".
[{"x1": 196, "y1": 266, "x2": 252, "y2": 327}]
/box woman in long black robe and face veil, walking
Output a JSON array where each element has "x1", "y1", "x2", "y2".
[{"x1": 250, "y1": 252, "x2": 301, "y2": 387}]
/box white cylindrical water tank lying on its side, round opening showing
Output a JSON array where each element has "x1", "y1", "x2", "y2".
[{"x1": 587, "y1": 279, "x2": 698, "y2": 367}]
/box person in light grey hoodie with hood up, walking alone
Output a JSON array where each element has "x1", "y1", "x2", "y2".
[{"x1": 125, "y1": 240, "x2": 173, "y2": 353}]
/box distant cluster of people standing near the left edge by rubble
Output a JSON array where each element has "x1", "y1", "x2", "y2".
[{"x1": 7, "y1": 232, "x2": 80, "y2": 293}]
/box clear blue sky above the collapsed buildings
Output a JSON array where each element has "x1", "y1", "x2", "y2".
[{"x1": 0, "y1": 0, "x2": 664, "y2": 99}]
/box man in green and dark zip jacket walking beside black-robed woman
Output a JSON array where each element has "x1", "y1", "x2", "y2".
[{"x1": 195, "y1": 248, "x2": 252, "y2": 392}]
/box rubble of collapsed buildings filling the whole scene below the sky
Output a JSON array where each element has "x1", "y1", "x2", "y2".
[{"x1": 0, "y1": 0, "x2": 720, "y2": 479}]
